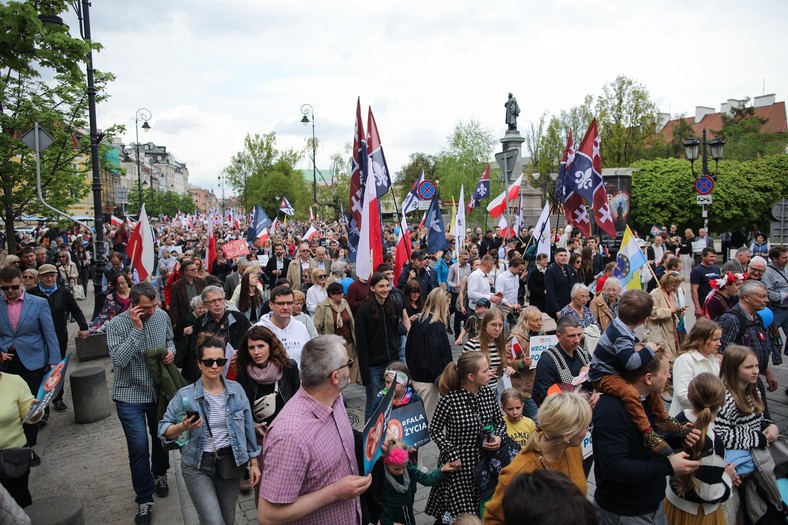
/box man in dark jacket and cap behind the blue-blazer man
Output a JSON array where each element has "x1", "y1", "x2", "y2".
[{"x1": 26, "y1": 264, "x2": 90, "y2": 412}]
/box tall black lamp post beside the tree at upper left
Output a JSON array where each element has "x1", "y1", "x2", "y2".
[{"x1": 38, "y1": 0, "x2": 106, "y2": 295}]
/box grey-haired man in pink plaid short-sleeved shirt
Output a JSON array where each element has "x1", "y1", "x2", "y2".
[{"x1": 257, "y1": 335, "x2": 372, "y2": 525}]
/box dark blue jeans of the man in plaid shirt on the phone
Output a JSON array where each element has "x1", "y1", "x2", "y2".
[{"x1": 115, "y1": 401, "x2": 170, "y2": 503}]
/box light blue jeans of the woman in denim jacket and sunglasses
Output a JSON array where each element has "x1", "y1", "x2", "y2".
[{"x1": 181, "y1": 452, "x2": 239, "y2": 525}]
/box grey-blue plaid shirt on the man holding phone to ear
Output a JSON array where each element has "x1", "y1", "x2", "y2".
[{"x1": 107, "y1": 308, "x2": 175, "y2": 403}]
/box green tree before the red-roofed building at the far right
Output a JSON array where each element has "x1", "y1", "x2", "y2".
[{"x1": 712, "y1": 98, "x2": 788, "y2": 160}]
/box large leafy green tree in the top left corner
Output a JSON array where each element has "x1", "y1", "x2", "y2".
[{"x1": 0, "y1": 0, "x2": 112, "y2": 251}]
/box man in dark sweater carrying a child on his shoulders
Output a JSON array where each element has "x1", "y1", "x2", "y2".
[{"x1": 592, "y1": 351, "x2": 700, "y2": 525}]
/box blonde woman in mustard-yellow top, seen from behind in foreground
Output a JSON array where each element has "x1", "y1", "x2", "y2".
[{"x1": 484, "y1": 392, "x2": 591, "y2": 525}]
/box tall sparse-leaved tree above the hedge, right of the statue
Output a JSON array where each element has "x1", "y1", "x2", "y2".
[{"x1": 596, "y1": 75, "x2": 657, "y2": 166}]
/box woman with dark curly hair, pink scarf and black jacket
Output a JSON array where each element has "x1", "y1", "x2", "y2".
[{"x1": 234, "y1": 326, "x2": 301, "y2": 504}]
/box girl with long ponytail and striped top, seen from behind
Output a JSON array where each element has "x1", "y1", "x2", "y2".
[{"x1": 665, "y1": 372, "x2": 740, "y2": 525}]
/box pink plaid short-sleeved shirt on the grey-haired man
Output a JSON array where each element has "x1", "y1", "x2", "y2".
[{"x1": 260, "y1": 388, "x2": 361, "y2": 525}]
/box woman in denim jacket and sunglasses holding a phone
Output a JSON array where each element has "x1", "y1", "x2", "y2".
[{"x1": 159, "y1": 333, "x2": 261, "y2": 525}]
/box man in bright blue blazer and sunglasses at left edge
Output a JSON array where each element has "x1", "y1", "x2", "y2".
[{"x1": 0, "y1": 267, "x2": 60, "y2": 447}]
